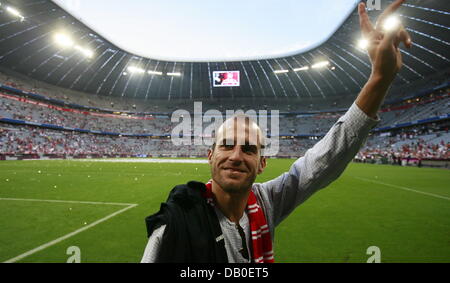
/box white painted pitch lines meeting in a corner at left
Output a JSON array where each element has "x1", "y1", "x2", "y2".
[{"x1": 0, "y1": 198, "x2": 137, "y2": 263}]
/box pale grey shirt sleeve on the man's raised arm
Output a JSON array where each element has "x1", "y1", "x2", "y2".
[{"x1": 254, "y1": 103, "x2": 379, "y2": 229}]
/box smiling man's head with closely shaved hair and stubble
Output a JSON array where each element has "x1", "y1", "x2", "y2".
[{"x1": 208, "y1": 119, "x2": 266, "y2": 193}]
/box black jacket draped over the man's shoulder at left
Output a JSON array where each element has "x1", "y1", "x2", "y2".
[{"x1": 145, "y1": 181, "x2": 228, "y2": 263}]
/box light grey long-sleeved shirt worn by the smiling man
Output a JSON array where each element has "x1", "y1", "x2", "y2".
[{"x1": 141, "y1": 103, "x2": 379, "y2": 263}]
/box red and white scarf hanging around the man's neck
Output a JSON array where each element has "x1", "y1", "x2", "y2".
[{"x1": 205, "y1": 181, "x2": 275, "y2": 263}]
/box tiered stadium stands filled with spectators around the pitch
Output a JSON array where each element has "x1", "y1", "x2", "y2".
[{"x1": 0, "y1": 71, "x2": 450, "y2": 166}]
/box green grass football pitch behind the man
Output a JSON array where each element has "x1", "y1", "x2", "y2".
[{"x1": 0, "y1": 160, "x2": 450, "y2": 262}]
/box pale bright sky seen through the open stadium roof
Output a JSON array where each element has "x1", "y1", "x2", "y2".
[{"x1": 54, "y1": 0, "x2": 359, "y2": 62}]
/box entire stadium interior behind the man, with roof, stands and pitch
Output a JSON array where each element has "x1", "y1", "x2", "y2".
[{"x1": 0, "y1": 0, "x2": 450, "y2": 263}]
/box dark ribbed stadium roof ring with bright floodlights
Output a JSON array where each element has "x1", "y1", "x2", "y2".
[{"x1": 0, "y1": 0, "x2": 450, "y2": 100}]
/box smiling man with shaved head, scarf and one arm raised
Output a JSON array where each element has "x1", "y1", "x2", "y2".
[{"x1": 142, "y1": 0, "x2": 412, "y2": 263}]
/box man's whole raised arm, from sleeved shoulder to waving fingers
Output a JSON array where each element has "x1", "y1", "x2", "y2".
[{"x1": 255, "y1": 0, "x2": 411, "y2": 229}]
